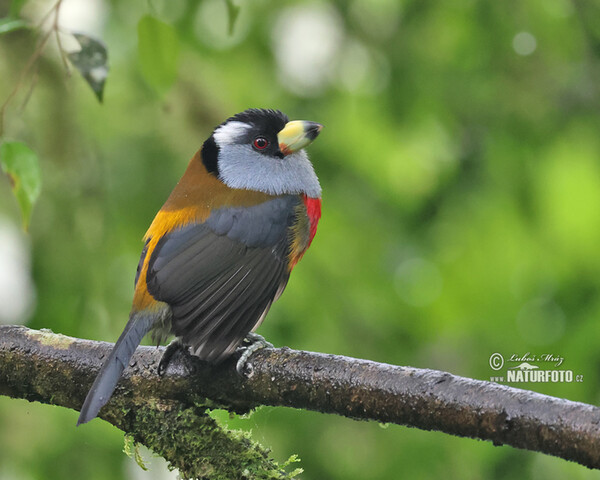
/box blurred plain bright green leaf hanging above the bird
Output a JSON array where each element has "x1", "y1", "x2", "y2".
[{"x1": 138, "y1": 15, "x2": 179, "y2": 94}]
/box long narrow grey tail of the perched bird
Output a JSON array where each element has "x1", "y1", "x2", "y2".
[{"x1": 77, "y1": 314, "x2": 155, "y2": 425}]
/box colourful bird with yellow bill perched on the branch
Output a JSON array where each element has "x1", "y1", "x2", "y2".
[{"x1": 77, "y1": 108, "x2": 323, "y2": 425}]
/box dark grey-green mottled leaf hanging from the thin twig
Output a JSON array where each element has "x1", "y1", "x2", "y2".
[{"x1": 69, "y1": 33, "x2": 108, "y2": 103}]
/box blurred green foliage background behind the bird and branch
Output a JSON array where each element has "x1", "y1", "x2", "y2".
[{"x1": 0, "y1": 0, "x2": 600, "y2": 480}]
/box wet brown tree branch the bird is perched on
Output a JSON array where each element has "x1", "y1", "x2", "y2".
[{"x1": 0, "y1": 326, "x2": 600, "y2": 472}]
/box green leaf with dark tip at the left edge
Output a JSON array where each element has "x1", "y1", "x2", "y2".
[{"x1": 0, "y1": 142, "x2": 42, "y2": 230}]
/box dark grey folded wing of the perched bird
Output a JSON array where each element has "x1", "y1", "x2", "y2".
[{"x1": 146, "y1": 195, "x2": 300, "y2": 362}]
